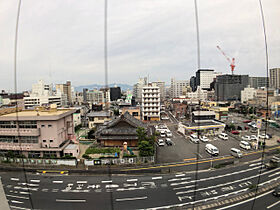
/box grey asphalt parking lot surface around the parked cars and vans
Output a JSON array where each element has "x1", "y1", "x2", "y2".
[{"x1": 157, "y1": 113, "x2": 279, "y2": 163}]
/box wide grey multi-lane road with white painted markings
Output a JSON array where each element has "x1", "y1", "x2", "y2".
[{"x1": 0, "y1": 161, "x2": 280, "y2": 210}]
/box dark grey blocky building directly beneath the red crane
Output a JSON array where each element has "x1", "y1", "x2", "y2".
[{"x1": 215, "y1": 74, "x2": 249, "y2": 101}]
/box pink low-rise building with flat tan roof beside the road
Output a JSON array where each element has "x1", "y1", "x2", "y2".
[{"x1": 0, "y1": 104, "x2": 79, "y2": 157}]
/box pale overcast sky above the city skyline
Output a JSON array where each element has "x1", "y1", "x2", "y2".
[{"x1": 0, "y1": 0, "x2": 280, "y2": 92}]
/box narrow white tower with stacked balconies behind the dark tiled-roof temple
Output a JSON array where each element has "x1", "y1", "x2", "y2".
[{"x1": 142, "y1": 84, "x2": 160, "y2": 121}]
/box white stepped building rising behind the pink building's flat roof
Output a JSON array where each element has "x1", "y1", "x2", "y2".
[{"x1": 23, "y1": 80, "x2": 67, "y2": 109}]
